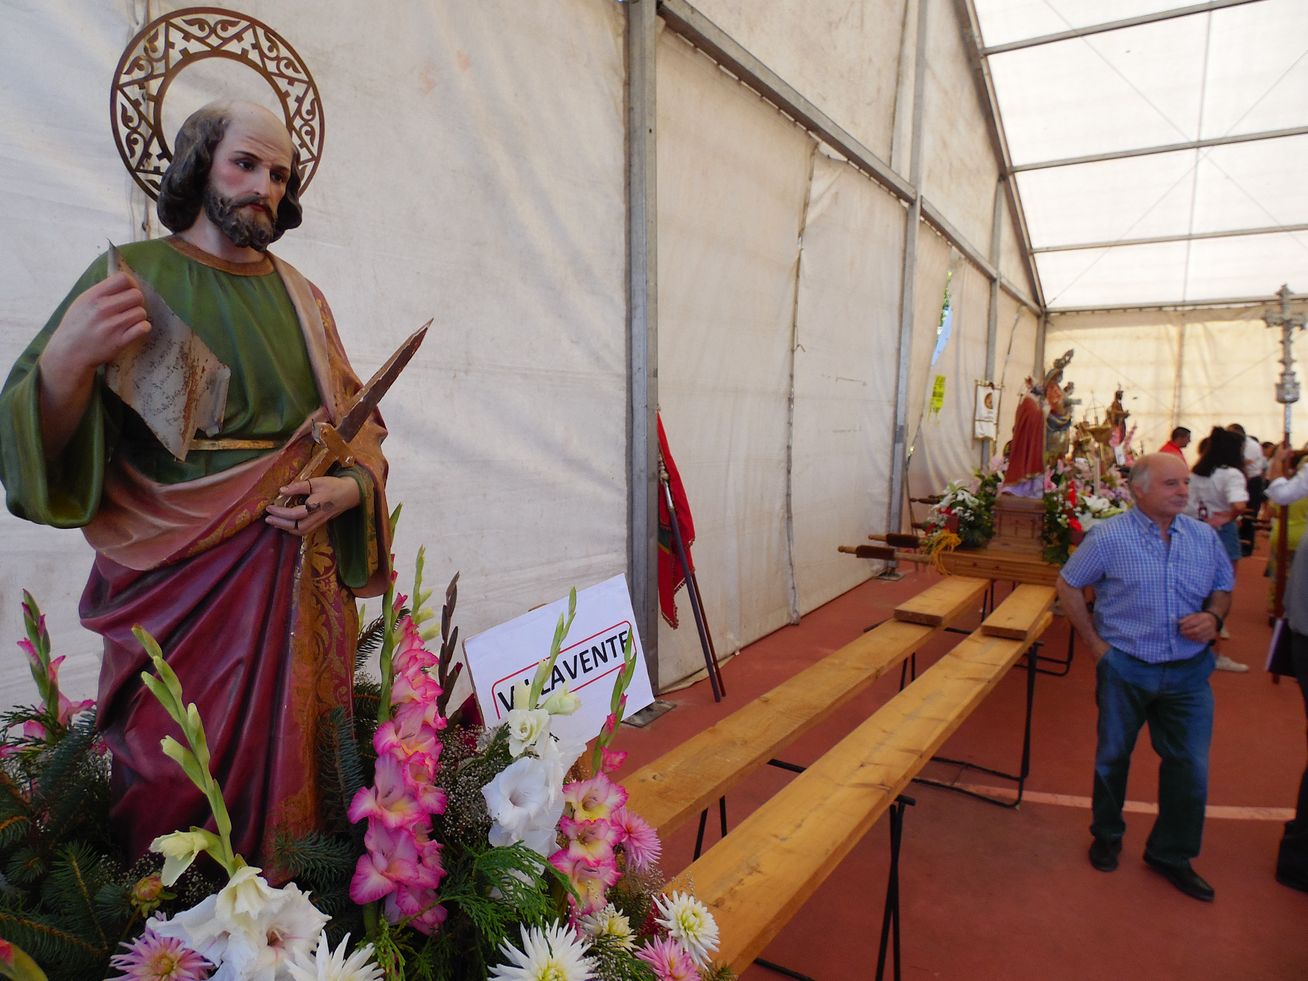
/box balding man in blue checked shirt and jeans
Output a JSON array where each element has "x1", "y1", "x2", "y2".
[{"x1": 1058, "y1": 453, "x2": 1235, "y2": 901}]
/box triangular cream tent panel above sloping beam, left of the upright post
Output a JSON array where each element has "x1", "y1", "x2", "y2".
[{"x1": 693, "y1": 0, "x2": 912, "y2": 161}]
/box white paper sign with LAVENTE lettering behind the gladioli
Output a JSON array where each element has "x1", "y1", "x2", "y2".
[{"x1": 463, "y1": 576, "x2": 654, "y2": 740}]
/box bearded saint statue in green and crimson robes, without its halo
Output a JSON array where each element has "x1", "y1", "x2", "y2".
[{"x1": 0, "y1": 103, "x2": 390, "y2": 862}]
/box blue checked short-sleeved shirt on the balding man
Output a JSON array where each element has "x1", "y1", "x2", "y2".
[{"x1": 1062, "y1": 508, "x2": 1235, "y2": 663}]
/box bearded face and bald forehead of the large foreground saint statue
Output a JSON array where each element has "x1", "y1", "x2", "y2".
[{"x1": 204, "y1": 106, "x2": 292, "y2": 252}]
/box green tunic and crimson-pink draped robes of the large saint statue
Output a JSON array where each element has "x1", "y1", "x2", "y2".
[{"x1": 0, "y1": 238, "x2": 390, "y2": 863}]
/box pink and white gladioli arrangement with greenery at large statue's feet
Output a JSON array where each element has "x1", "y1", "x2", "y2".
[{"x1": 0, "y1": 531, "x2": 731, "y2": 981}]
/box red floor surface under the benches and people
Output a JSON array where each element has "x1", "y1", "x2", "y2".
[{"x1": 619, "y1": 556, "x2": 1308, "y2": 981}]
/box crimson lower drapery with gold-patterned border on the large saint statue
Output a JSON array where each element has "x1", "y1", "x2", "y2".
[{"x1": 81, "y1": 521, "x2": 358, "y2": 862}]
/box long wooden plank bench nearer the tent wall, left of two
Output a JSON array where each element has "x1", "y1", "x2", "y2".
[{"x1": 623, "y1": 577, "x2": 989, "y2": 836}]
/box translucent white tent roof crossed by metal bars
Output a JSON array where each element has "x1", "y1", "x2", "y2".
[{"x1": 972, "y1": 0, "x2": 1308, "y2": 310}]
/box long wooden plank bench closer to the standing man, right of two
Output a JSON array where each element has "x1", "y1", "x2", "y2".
[{"x1": 670, "y1": 586, "x2": 1054, "y2": 973}]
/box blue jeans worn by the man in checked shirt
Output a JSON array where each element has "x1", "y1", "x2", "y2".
[{"x1": 1090, "y1": 647, "x2": 1214, "y2": 865}]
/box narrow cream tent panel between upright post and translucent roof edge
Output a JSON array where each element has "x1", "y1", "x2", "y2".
[{"x1": 921, "y1": 4, "x2": 999, "y2": 258}]
